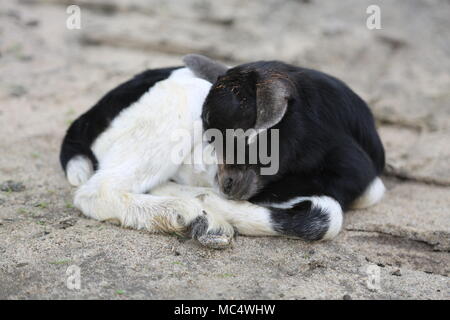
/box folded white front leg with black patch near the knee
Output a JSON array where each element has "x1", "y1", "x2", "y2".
[{"x1": 155, "y1": 183, "x2": 342, "y2": 243}]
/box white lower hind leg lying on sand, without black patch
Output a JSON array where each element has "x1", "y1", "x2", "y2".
[{"x1": 74, "y1": 172, "x2": 206, "y2": 235}]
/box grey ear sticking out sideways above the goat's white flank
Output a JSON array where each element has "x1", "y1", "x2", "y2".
[{"x1": 183, "y1": 54, "x2": 228, "y2": 83}]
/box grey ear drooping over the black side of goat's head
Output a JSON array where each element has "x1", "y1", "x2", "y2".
[{"x1": 255, "y1": 76, "x2": 293, "y2": 131}]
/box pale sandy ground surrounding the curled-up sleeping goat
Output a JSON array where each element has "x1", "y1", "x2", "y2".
[{"x1": 0, "y1": 0, "x2": 450, "y2": 299}]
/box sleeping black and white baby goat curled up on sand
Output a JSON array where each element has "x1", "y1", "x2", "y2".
[{"x1": 60, "y1": 55, "x2": 384, "y2": 248}]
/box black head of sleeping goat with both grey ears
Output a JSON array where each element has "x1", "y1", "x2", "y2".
[{"x1": 184, "y1": 55, "x2": 295, "y2": 200}]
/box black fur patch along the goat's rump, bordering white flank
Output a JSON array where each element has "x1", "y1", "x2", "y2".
[{"x1": 60, "y1": 67, "x2": 179, "y2": 171}]
